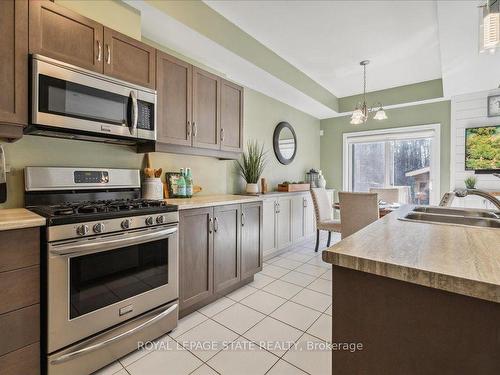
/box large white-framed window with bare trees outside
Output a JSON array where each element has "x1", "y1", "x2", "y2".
[{"x1": 344, "y1": 125, "x2": 439, "y2": 204}]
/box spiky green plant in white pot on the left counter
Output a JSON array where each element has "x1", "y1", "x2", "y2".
[{"x1": 236, "y1": 141, "x2": 266, "y2": 194}]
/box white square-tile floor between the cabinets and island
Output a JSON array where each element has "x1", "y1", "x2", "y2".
[{"x1": 95, "y1": 235, "x2": 340, "y2": 375}]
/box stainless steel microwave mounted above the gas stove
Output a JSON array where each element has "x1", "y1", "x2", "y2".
[{"x1": 26, "y1": 55, "x2": 156, "y2": 144}]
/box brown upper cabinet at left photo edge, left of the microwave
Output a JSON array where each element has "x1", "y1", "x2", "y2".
[{"x1": 0, "y1": 0, "x2": 28, "y2": 139}]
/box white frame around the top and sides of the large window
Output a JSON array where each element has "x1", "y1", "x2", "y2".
[{"x1": 342, "y1": 124, "x2": 441, "y2": 205}]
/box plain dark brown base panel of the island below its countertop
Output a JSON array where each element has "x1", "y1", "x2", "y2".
[{"x1": 331, "y1": 266, "x2": 500, "y2": 375}]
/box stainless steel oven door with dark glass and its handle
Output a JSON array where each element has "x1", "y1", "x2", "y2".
[{"x1": 47, "y1": 225, "x2": 179, "y2": 353}]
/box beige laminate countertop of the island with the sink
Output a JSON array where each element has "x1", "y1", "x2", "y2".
[{"x1": 323, "y1": 206, "x2": 500, "y2": 303}]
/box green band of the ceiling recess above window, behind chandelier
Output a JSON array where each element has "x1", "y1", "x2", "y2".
[{"x1": 339, "y1": 79, "x2": 443, "y2": 113}]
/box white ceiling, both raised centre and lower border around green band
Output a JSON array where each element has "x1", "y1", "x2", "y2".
[{"x1": 122, "y1": 0, "x2": 500, "y2": 118}]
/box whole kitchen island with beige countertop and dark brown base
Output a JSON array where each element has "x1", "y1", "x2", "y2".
[{"x1": 323, "y1": 206, "x2": 500, "y2": 374}]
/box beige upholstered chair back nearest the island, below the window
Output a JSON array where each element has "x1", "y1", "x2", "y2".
[{"x1": 339, "y1": 191, "x2": 379, "y2": 239}]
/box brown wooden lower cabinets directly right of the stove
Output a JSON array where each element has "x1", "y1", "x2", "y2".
[{"x1": 179, "y1": 202, "x2": 262, "y2": 316}]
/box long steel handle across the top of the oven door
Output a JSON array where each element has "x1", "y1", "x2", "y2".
[{"x1": 49, "y1": 227, "x2": 177, "y2": 255}]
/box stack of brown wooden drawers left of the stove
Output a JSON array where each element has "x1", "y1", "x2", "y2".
[{"x1": 0, "y1": 228, "x2": 40, "y2": 375}]
